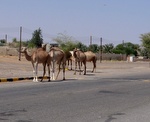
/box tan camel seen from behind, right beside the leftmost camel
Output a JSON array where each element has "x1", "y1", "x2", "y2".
[{"x1": 47, "y1": 47, "x2": 66, "y2": 81}]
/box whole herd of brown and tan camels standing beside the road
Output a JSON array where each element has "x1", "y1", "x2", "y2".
[{"x1": 20, "y1": 44, "x2": 97, "y2": 82}]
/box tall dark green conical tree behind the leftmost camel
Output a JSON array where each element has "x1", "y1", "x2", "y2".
[{"x1": 29, "y1": 28, "x2": 43, "y2": 48}]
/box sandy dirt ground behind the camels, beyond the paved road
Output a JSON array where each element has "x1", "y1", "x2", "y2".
[{"x1": 0, "y1": 56, "x2": 150, "y2": 80}]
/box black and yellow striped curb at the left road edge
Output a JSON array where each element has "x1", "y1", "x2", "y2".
[{"x1": 0, "y1": 76, "x2": 49, "y2": 82}]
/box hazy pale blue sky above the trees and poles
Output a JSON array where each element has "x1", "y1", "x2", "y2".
[{"x1": 0, "y1": 0, "x2": 150, "y2": 45}]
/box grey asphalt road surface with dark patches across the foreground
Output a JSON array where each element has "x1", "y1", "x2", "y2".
[{"x1": 0, "y1": 73, "x2": 150, "y2": 122}]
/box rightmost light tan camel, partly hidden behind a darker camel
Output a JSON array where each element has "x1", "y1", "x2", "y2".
[{"x1": 84, "y1": 51, "x2": 97, "y2": 72}]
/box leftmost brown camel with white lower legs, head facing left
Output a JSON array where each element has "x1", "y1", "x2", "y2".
[{"x1": 21, "y1": 46, "x2": 48, "y2": 82}]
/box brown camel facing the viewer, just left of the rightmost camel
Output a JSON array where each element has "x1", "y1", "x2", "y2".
[{"x1": 73, "y1": 48, "x2": 86, "y2": 75}]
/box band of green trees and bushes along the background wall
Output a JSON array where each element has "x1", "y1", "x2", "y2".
[{"x1": 0, "y1": 28, "x2": 150, "y2": 58}]
